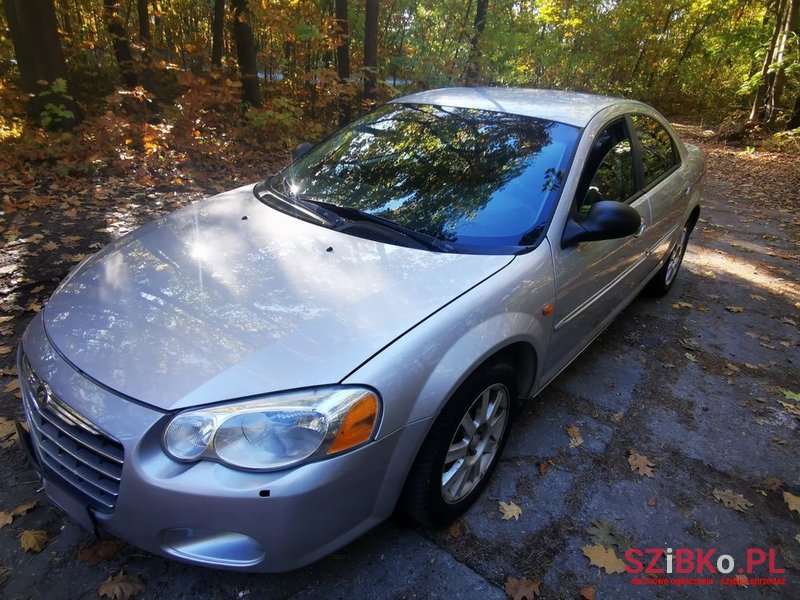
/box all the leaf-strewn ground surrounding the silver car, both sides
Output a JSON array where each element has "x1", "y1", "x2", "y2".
[{"x1": 0, "y1": 127, "x2": 800, "y2": 600}]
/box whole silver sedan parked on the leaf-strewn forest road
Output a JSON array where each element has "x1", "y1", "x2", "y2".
[{"x1": 18, "y1": 88, "x2": 705, "y2": 571}]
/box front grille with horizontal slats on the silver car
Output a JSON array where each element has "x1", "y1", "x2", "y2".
[{"x1": 21, "y1": 358, "x2": 124, "y2": 513}]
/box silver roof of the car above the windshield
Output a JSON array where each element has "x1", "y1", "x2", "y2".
[{"x1": 393, "y1": 87, "x2": 642, "y2": 127}]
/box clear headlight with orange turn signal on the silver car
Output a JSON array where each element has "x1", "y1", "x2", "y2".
[{"x1": 164, "y1": 386, "x2": 380, "y2": 471}]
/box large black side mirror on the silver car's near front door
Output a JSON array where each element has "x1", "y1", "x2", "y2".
[{"x1": 561, "y1": 200, "x2": 642, "y2": 248}]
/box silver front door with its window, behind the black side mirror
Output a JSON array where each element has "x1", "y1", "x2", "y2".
[{"x1": 544, "y1": 117, "x2": 650, "y2": 376}]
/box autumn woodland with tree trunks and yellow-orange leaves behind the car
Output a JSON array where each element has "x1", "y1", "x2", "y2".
[{"x1": 0, "y1": 0, "x2": 800, "y2": 193}]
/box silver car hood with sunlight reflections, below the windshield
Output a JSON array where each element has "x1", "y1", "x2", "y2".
[{"x1": 43, "y1": 185, "x2": 513, "y2": 410}]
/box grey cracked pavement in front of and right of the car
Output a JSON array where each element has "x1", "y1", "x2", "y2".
[{"x1": 0, "y1": 134, "x2": 800, "y2": 600}]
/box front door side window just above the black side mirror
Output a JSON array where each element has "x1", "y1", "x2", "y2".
[{"x1": 577, "y1": 119, "x2": 636, "y2": 216}]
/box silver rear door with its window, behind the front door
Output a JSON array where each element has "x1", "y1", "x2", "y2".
[{"x1": 630, "y1": 114, "x2": 692, "y2": 270}]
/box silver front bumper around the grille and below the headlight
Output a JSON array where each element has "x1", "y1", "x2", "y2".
[{"x1": 20, "y1": 317, "x2": 428, "y2": 572}]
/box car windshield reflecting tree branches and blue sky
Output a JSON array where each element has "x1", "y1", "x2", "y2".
[{"x1": 271, "y1": 103, "x2": 579, "y2": 253}]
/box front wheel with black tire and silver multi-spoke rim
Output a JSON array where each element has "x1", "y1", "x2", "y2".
[{"x1": 400, "y1": 362, "x2": 517, "y2": 527}]
